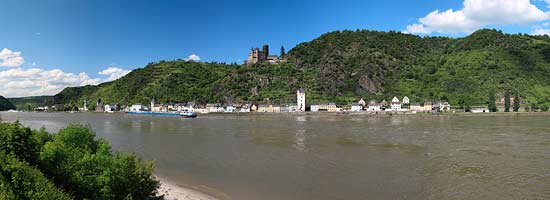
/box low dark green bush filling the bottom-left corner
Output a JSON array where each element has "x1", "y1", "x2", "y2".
[{"x1": 0, "y1": 151, "x2": 71, "y2": 200}]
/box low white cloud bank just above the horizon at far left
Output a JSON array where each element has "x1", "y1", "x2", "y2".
[{"x1": 0, "y1": 68, "x2": 102, "y2": 97}]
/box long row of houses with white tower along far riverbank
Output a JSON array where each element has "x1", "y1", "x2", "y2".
[{"x1": 82, "y1": 89, "x2": 458, "y2": 113}]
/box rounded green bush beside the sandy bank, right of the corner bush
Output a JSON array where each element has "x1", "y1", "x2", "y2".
[{"x1": 40, "y1": 125, "x2": 159, "y2": 199}]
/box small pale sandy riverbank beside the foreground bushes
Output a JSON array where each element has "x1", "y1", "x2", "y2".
[{"x1": 156, "y1": 177, "x2": 219, "y2": 200}]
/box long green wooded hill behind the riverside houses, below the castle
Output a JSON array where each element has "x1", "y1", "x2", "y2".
[{"x1": 54, "y1": 30, "x2": 550, "y2": 107}]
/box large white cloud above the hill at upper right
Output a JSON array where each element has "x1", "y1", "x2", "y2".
[{"x1": 403, "y1": 0, "x2": 550, "y2": 34}]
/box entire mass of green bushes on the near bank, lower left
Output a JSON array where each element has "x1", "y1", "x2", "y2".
[{"x1": 0, "y1": 122, "x2": 162, "y2": 199}]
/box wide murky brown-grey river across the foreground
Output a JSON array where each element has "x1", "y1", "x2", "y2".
[{"x1": 0, "y1": 112, "x2": 550, "y2": 200}]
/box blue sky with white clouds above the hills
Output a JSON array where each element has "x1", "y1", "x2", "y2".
[{"x1": 0, "y1": 0, "x2": 550, "y2": 96}]
